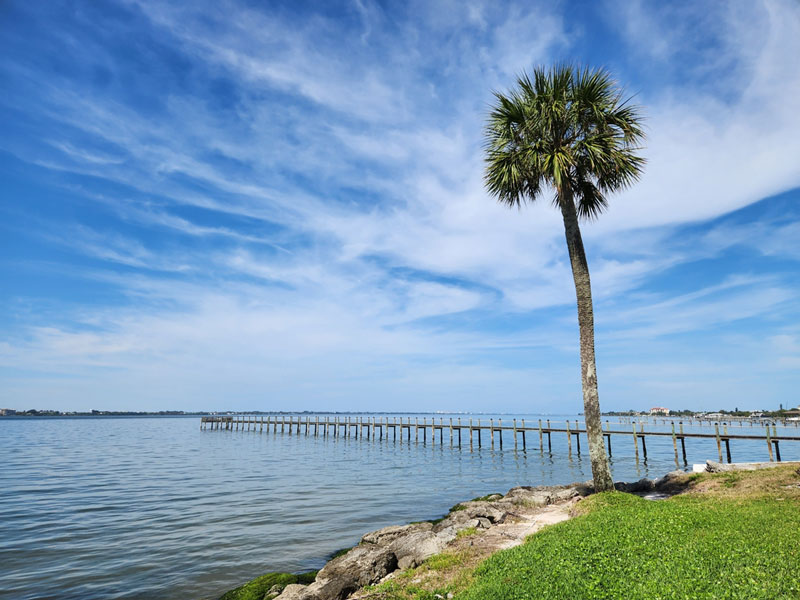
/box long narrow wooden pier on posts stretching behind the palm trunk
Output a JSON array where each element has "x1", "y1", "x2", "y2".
[{"x1": 200, "y1": 415, "x2": 800, "y2": 467}]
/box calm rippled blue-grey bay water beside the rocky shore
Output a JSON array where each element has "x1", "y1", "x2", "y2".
[{"x1": 0, "y1": 416, "x2": 800, "y2": 600}]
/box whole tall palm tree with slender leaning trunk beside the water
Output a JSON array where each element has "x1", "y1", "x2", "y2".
[{"x1": 484, "y1": 64, "x2": 645, "y2": 491}]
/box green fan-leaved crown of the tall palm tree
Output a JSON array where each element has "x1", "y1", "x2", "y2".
[{"x1": 485, "y1": 65, "x2": 644, "y2": 218}]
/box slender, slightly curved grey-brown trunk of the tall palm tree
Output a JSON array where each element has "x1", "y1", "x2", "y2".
[{"x1": 560, "y1": 194, "x2": 614, "y2": 492}]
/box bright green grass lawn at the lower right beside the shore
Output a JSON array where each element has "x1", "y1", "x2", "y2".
[{"x1": 456, "y1": 467, "x2": 800, "y2": 600}]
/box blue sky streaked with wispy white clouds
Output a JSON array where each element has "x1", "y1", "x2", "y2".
[{"x1": 0, "y1": 0, "x2": 800, "y2": 413}]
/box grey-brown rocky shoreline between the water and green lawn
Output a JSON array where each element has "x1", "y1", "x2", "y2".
[{"x1": 226, "y1": 471, "x2": 686, "y2": 600}]
